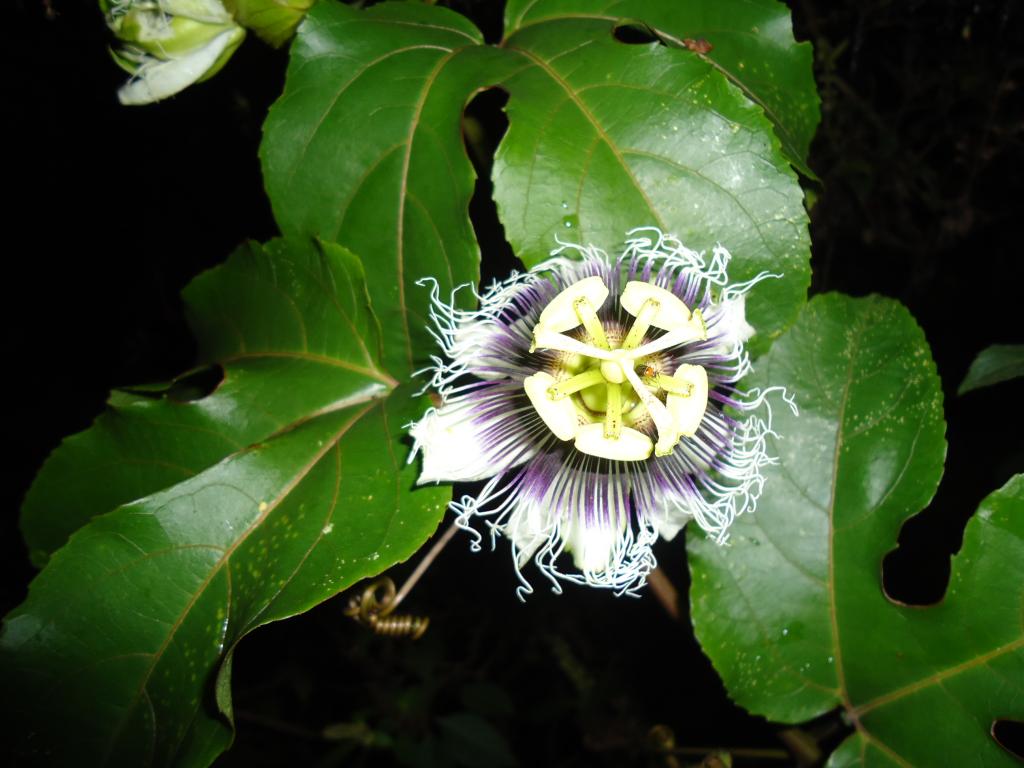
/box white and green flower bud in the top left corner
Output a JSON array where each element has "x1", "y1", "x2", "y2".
[{"x1": 99, "y1": 0, "x2": 246, "y2": 104}]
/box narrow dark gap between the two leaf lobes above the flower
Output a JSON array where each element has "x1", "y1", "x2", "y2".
[{"x1": 462, "y1": 88, "x2": 522, "y2": 285}]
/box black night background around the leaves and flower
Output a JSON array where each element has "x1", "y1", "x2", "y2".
[{"x1": 8, "y1": 0, "x2": 1024, "y2": 766}]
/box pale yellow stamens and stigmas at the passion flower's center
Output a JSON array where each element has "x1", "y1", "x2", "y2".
[{"x1": 523, "y1": 276, "x2": 708, "y2": 461}]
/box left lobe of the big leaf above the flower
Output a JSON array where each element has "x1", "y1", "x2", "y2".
[{"x1": 260, "y1": 2, "x2": 520, "y2": 374}]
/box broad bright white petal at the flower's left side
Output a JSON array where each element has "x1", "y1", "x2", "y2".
[{"x1": 409, "y1": 406, "x2": 534, "y2": 485}]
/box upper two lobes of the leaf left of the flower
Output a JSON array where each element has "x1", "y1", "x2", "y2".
[{"x1": 22, "y1": 241, "x2": 396, "y2": 565}]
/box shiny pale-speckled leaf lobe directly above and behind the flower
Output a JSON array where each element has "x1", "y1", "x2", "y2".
[{"x1": 495, "y1": 18, "x2": 810, "y2": 349}]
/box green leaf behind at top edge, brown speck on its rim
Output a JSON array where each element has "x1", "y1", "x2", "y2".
[{"x1": 505, "y1": 0, "x2": 821, "y2": 178}]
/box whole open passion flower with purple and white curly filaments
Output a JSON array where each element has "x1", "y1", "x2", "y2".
[{"x1": 410, "y1": 228, "x2": 796, "y2": 597}]
